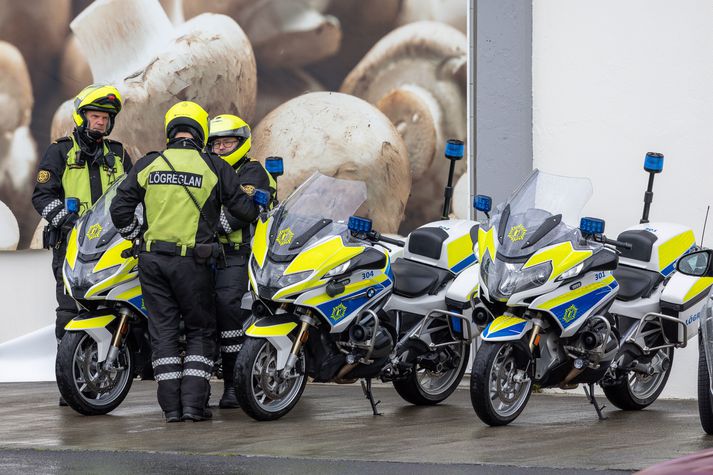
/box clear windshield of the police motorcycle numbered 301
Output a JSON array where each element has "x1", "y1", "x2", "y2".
[{"x1": 490, "y1": 169, "x2": 592, "y2": 259}]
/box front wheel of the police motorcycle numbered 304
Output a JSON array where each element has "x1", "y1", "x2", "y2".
[{"x1": 235, "y1": 337, "x2": 307, "y2": 421}]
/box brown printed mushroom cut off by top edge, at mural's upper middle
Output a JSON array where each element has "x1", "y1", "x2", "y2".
[{"x1": 183, "y1": 0, "x2": 342, "y2": 68}]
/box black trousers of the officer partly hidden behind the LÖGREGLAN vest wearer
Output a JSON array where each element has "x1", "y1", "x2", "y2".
[{"x1": 215, "y1": 254, "x2": 250, "y2": 385}]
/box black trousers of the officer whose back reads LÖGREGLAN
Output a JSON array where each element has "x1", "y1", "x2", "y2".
[{"x1": 139, "y1": 252, "x2": 216, "y2": 412}]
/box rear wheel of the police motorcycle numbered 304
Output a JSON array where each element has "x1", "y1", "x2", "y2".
[{"x1": 393, "y1": 342, "x2": 470, "y2": 406}]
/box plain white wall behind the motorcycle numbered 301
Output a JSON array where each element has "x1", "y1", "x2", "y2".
[{"x1": 532, "y1": 0, "x2": 713, "y2": 397}]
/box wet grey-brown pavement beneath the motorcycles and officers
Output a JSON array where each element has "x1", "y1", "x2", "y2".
[{"x1": 0, "y1": 381, "x2": 713, "y2": 475}]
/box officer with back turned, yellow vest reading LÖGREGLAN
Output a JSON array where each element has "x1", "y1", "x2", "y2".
[{"x1": 110, "y1": 101, "x2": 258, "y2": 422}]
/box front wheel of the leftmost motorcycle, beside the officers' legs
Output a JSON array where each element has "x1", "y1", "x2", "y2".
[{"x1": 55, "y1": 332, "x2": 134, "y2": 416}]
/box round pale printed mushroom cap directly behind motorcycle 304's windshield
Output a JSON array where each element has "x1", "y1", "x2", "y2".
[{"x1": 252, "y1": 92, "x2": 411, "y2": 232}]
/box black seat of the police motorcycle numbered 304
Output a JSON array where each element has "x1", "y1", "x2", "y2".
[{"x1": 391, "y1": 259, "x2": 453, "y2": 298}]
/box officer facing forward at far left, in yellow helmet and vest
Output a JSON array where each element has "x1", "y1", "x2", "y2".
[{"x1": 32, "y1": 84, "x2": 131, "y2": 340}]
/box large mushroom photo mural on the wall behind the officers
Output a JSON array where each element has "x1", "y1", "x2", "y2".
[{"x1": 0, "y1": 0, "x2": 469, "y2": 247}]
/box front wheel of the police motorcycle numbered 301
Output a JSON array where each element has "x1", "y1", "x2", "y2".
[{"x1": 470, "y1": 341, "x2": 532, "y2": 426}]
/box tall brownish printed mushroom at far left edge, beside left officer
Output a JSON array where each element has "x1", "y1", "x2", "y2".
[{"x1": 0, "y1": 41, "x2": 39, "y2": 249}]
